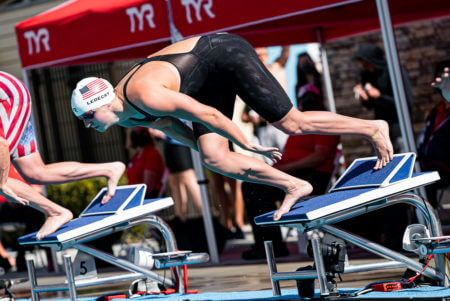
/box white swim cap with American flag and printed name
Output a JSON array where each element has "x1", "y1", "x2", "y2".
[{"x1": 72, "y1": 77, "x2": 115, "y2": 117}]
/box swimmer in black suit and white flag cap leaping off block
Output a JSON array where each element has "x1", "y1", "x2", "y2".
[{"x1": 72, "y1": 33, "x2": 393, "y2": 220}]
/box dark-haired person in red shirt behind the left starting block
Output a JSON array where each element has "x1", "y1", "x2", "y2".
[{"x1": 127, "y1": 127, "x2": 164, "y2": 198}]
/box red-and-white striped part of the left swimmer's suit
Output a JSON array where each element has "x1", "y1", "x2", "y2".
[{"x1": 0, "y1": 71, "x2": 31, "y2": 154}]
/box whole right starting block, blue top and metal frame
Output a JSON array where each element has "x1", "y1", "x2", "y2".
[{"x1": 255, "y1": 153, "x2": 449, "y2": 297}]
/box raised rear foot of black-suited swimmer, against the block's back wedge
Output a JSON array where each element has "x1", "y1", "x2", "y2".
[{"x1": 371, "y1": 120, "x2": 394, "y2": 170}]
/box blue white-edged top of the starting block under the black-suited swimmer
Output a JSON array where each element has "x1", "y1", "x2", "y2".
[{"x1": 255, "y1": 153, "x2": 439, "y2": 226}]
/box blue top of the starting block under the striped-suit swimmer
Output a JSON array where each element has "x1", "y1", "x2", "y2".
[{"x1": 19, "y1": 184, "x2": 173, "y2": 245}]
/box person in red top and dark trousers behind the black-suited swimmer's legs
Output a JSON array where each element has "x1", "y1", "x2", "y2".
[{"x1": 242, "y1": 57, "x2": 340, "y2": 260}]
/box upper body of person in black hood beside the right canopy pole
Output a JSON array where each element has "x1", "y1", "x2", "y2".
[{"x1": 353, "y1": 43, "x2": 413, "y2": 153}]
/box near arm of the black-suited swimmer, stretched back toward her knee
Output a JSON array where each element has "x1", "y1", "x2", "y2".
[{"x1": 138, "y1": 87, "x2": 281, "y2": 162}]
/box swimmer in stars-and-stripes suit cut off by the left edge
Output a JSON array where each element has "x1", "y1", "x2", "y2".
[{"x1": 0, "y1": 71, "x2": 125, "y2": 239}]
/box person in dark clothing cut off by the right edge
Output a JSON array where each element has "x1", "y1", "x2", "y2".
[{"x1": 418, "y1": 61, "x2": 450, "y2": 209}]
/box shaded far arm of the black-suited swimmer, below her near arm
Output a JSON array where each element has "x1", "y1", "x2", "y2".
[{"x1": 150, "y1": 117, "x2": 198, "y2": 151}]
